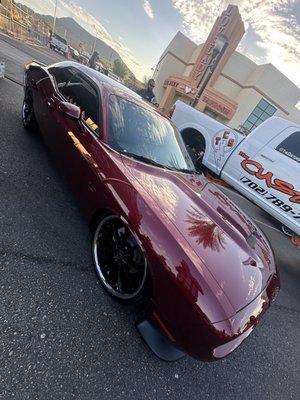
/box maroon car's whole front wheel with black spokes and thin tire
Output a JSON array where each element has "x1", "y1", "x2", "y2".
[{"x1": 92, "y1": 214, "x2": 150, "y2": 304}]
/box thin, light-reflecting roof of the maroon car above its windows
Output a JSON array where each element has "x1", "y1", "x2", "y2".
[{"x1": 51, "y1": 61, "x2": 162, "y2": 115}]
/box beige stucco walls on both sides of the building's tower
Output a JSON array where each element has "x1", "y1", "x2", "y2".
[{"x1": 154, "y1": 32, "x2": 300, "y2": 128}]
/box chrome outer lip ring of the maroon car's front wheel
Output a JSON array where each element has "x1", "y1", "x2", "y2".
[{"x1": 92, "y1": 215, "x2": 147, "y2": 300}]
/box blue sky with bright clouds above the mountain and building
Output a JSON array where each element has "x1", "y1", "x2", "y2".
[{"x1": 19, "y1": 0, "x2": 300, "y2": 87}]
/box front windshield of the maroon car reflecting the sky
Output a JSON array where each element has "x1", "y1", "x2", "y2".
[{"x1": 108, "y1": 95, "x2": 196, "y2": 173}]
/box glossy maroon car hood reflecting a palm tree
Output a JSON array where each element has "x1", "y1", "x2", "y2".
[{"x1": 122, "y1": 157, "x2": 275, "y2": 312}]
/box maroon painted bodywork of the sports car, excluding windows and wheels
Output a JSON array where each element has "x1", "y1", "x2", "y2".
[{"x1": 26, "y1": 62, "x2": 279, "y2": 360}]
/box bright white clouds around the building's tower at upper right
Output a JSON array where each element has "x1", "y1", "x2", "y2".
[{"x1": 172, "y1": 0, "x2": 300, "y2": 86}]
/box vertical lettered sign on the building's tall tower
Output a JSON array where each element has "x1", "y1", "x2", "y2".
[{"x1": 191, "y1": 6, "x2": 235, "y2": 86}]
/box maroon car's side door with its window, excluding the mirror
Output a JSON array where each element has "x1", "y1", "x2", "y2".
[{"x1": 46, "y1": 70, "x2": 120, "y2": 216}]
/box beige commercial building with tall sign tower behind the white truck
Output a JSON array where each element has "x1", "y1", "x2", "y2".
[{"x1": 154, "y1": 5, "x2": 300, "y2": 133}]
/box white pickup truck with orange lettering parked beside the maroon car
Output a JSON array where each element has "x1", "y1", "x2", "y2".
[{"x1": 170, "y1": 101, "x2": 300, "y2": 236}]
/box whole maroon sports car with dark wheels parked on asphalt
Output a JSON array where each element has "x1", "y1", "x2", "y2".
[{"x1": 22, "y1": 62, "x2": 279, "y2": 360}]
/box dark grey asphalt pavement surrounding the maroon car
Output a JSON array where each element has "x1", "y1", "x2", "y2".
[{"x1": 0, "y1": 36, "x2": 300, "y2": 400}]
